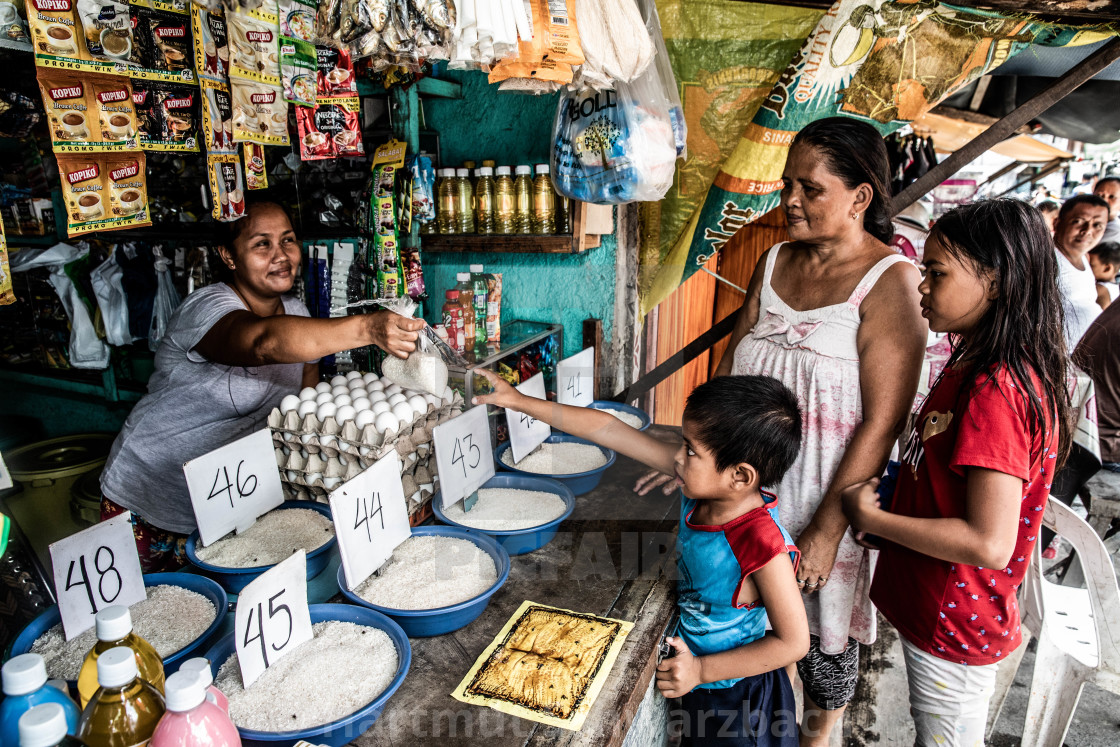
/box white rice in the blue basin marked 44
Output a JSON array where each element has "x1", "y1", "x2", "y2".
[{"x1": 354, "y1": 535, "x2": 497, "y2": 609}]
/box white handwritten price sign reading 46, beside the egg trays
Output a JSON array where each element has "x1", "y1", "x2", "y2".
[{"x1": 183, "y1": 428, "x2": 283, "y2": 545}]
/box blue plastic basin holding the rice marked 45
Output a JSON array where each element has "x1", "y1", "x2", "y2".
[{"x1": 206, "y1": 605, "x2": 412, "y2": 747}]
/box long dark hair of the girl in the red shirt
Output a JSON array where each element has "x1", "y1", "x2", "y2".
[{"x1": 930, "y1": 199, "x2": 1073, "y2": 466}]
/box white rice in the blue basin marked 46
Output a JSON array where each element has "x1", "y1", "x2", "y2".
[{"x1": 195, "y1": 508, "x2": 335, "y2": 568}]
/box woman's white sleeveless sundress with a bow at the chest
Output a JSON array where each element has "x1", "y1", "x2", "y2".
[{"x1": 731, "y1": 244, "x2": 907, "y2": 654}]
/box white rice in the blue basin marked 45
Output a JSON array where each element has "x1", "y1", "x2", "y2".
[{"x1": 214, "y1": 620, "x2": 399, "y2": 731}]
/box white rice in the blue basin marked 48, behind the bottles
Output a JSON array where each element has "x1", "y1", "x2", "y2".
[{"x1": 31, "y1": 583, "x2": 216, "y2": 680}]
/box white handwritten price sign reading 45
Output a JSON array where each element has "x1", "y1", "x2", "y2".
[{"x1": 233, "y1": 550, "x2": 312, "y2": 688}]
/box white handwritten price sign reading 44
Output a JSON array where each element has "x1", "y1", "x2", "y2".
[{"x1": 329, "y1": 450, "x2": 412, "y2": 591}]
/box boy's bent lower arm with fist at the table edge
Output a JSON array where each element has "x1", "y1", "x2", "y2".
[{"x1": 656, "y1": 552, "x2": 809, "y2": 698}]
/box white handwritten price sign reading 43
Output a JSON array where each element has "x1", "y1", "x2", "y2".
[{"x1": 431, "y1": 405, "x2": 494, "y2": 508}]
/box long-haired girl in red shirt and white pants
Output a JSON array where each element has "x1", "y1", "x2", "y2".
[{"x1": 843, "y1": 199, "x2": 1072, "y2": 746}]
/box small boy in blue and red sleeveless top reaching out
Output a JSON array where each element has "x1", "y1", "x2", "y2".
[{"x1": 474, "y1": 370, "x2": 809, "y2": 747}]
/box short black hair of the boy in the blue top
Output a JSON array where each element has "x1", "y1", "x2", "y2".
[{"x1": 684, "y1": 376, "x2": 801, "y2": 486}]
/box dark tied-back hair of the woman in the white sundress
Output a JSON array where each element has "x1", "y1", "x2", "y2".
[{"x1": 790, "y1": 116, "x2": 895, "y2": 244}]
